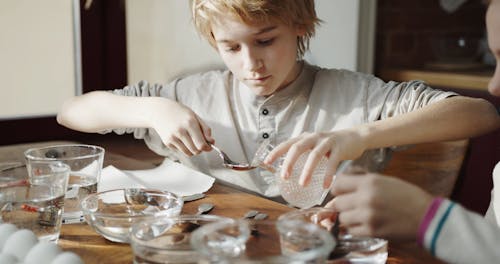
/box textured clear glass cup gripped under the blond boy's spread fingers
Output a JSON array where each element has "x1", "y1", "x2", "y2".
[{"x1": 252, "y1": 140, "x2": 346, "y2": 208}]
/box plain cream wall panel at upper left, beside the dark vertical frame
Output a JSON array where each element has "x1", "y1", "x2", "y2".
[{"x1": 0, "y1": 0, "x2": 76, "y2": 119}]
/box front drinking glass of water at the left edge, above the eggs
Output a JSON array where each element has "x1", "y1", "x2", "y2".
[{"x1": 0, "y1": 160, "x2": 70, "y2": 242}]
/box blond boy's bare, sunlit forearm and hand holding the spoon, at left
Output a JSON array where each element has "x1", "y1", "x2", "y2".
[{"x1": 57, "y1": 91, "x2": 213, "y2": 156}]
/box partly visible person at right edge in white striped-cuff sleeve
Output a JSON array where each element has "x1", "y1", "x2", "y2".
[{"x1": 326, "y1": 0, "x2": 500, "y2": 263}]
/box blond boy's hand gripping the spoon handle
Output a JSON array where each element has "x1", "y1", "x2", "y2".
[{"x1": 151, "y1": 100, "x2": 214, "y2": 156}]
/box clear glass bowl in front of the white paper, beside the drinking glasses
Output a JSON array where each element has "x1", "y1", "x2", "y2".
[{"x1": 80, "y1": 188, "x2": 184, "y2": 243}]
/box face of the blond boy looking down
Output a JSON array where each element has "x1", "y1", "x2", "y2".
[{"x1": 212, "y1": 16, "x2": 300, "y2": 96}]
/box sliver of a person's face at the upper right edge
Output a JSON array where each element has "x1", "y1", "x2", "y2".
[{"x1": 486, "y1": 0, "x2": 500, "y2": 96}]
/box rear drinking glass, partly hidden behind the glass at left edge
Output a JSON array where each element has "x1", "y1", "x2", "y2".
[{"x1": 24, "y1": 144, "x2": 104, "y2": 224}]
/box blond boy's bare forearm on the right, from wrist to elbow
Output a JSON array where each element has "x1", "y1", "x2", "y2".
[{"x1": 357, "y1": 96, "x2": 500, "y2": 149}]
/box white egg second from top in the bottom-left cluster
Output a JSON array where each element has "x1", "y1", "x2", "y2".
[{"x1": 2, "y1": 229, "x2": 38, "y2": 261}]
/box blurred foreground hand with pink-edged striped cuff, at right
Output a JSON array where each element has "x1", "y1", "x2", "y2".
[{"x1": 325, "y1": 173, "x2": 433, "y2": 240}]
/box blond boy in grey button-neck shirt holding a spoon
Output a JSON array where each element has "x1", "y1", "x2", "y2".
[{"x1": 57, "y1": 0, "x2": 496, "y2": 202}]
